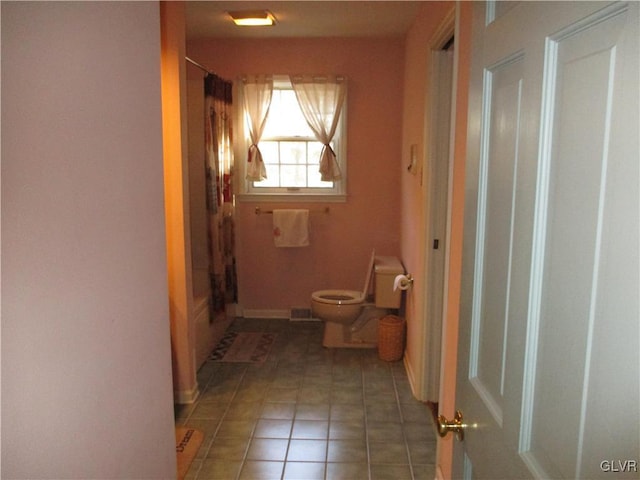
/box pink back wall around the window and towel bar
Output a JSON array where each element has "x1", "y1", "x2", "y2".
[{"x1": 187, "y1": 38, "x2": 404, "y2": 310}]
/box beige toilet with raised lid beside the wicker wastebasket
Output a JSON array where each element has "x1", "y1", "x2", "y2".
[{"x1": 311, "y1": 250, "x2": 404, "y2": 348}]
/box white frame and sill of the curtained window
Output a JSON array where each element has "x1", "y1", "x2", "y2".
[{"x1": 234, "y1": 75, "x2": 347, "y2": 202}]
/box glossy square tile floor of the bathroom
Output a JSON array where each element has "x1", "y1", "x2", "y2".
[{"x1": 176, "y1": 319, "x2": 436, "y2": 480}]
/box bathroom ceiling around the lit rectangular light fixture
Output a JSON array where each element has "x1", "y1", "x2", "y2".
[{"x1": 186, "y1": 0, "x2": 424, "y2": 40}]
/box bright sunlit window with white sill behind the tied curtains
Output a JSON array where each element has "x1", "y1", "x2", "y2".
[{"x1": 239, "y1": 77, "x2": 346, "y2": 201}]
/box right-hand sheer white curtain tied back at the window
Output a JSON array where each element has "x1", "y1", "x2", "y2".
[{"x1": 290, "y1": 76, "x2": 347, "y2": 182}]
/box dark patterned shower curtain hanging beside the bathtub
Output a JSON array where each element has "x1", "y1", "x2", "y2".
[{"x1": 204, "y1": 74, "x2": 238, "y2": 316}]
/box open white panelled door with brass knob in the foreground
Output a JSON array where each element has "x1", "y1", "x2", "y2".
[{"x1": 449, "y1": 2, "x2": 640, "y2": 479}]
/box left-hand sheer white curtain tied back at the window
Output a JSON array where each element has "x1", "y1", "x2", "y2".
[{"x1": 240, "y1": 75, "x2": 273, "y2": 182}]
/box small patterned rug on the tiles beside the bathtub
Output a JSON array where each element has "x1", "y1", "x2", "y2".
[{"x1": 209, "y1": 332, "x2": 276, "y2": 363}]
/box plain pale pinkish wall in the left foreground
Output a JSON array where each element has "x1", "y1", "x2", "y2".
[{"x1": 1, "y1": 2, "x2": 176, "y2": 479}]
